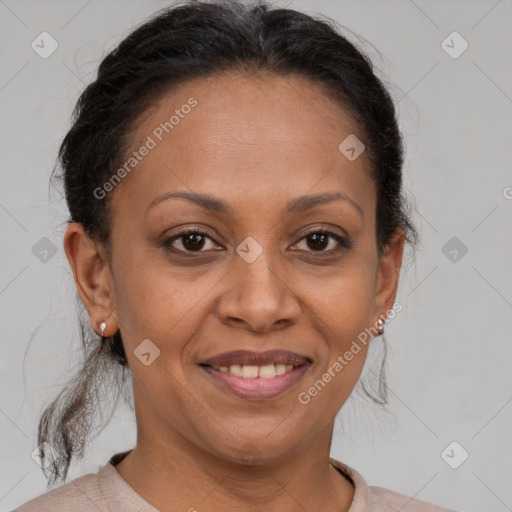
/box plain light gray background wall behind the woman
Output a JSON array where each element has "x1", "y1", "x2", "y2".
[{"x1": 0, "y1": 0, "x2": 512, "y2": 512}]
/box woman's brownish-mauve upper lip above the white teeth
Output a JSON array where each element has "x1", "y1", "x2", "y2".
[{"x1": 201, "y1": 350, "x2": 311, "y2": 366}]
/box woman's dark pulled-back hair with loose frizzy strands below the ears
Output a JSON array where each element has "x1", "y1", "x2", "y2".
[{"x1": 38, "y1": 0, "x2": 418, "y2": 485}]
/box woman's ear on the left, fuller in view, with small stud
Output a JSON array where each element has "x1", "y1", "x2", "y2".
[{"x1": 63, "y1": 222, "x2": 118, "y2": 337}]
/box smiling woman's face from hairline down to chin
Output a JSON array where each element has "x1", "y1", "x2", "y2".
[{"x1": 75, "y1": 72, "x2": 403, "y2": 460}]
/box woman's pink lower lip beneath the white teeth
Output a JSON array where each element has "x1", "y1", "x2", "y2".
[{"x1": 201, "y1": 364, "x2": 309, "y2": 400}]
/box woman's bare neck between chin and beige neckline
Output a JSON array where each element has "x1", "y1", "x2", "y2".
[{"x1": 116, "y1": 429, "x2": 354, "y2": 512}]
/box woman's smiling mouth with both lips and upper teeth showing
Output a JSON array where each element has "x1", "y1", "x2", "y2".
[{"x1": 199, "y1": 350, "x2": 312, "y2": 400}]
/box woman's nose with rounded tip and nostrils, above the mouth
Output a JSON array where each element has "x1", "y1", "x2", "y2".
[{"x1": 217, "y1": 246, "x2": 301, "y2": 332}]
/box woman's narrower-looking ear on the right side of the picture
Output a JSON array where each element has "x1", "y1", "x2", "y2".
[{"x1": 372, "y1": 228, "x2": 405, "y2": 325}]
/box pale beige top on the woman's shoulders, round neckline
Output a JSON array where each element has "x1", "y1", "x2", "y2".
[{"x1": 13, "y1": 450, "x2": 454, "y2": 512}]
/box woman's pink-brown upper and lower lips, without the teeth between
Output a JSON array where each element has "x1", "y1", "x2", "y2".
[{"x1": 199, "y1": 350, "x2": 312, "y2": 400}]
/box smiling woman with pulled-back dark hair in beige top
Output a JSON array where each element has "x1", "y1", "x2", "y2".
[{"x1": 17, "y1": 1, "x2": 452, "y2": 512}]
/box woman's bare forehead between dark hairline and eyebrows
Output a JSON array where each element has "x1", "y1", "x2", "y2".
[{"x1": 114, "y1": 72, "x2": 372, "y2": 217}]
